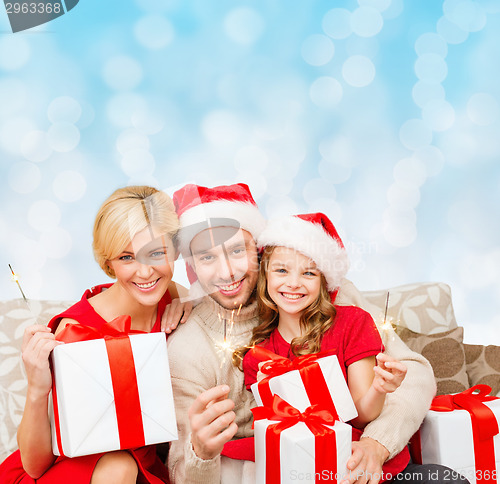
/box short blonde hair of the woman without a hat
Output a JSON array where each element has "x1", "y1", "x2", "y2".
[{"x1": 92, "y1": 186, "x2": 179, "y2": 278}]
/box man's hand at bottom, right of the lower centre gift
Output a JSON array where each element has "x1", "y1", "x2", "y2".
[{"x1": 341, "y1": 437, "x2": 389, "y2": 484}]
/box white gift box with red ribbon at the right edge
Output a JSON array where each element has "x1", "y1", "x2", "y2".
[{"x1": 411, "y1": 385, "x2": 500, "y2": 484}]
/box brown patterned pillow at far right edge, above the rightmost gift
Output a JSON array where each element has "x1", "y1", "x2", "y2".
[{"x1": 464, "y1": 344, "x2": 500, "y2": 395}]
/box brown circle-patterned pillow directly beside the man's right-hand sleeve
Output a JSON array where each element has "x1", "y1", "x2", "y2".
[{"x1": 395, "y1": 327, "x2": 469, "y2": 395}]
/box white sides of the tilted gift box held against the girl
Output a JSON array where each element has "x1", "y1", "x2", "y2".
[{"x1": 251, "y1": 355, "x2": 358, "y2": 422}]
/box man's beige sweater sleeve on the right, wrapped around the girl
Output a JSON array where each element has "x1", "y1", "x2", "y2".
[{"x1": 336, "y1": 279, "x2": 436, "y2": 459}]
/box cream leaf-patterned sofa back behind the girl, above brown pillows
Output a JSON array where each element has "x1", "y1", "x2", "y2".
[{"x1": 362, "y1": 282, "x2": 457, "y2": 334}]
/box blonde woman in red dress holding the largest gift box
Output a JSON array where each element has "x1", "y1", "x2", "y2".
[{"x1": 0, "y1": 186, "x2": 188, "y2": 484}]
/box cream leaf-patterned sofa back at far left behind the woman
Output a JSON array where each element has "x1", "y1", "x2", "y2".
[{"x1": 0, "y1": 299, "x2": 74, "y2": 462}]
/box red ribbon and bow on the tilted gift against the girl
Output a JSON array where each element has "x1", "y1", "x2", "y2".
[{"x1": 250, "y1": 346, "x2": 339, "y2": 420}]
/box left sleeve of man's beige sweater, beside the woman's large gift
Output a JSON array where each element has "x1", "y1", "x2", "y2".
[{"x1": 168, "y1": 321, "x2": 221, "y2": 484}]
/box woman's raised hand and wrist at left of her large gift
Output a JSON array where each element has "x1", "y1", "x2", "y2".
[{"x1": 21, "y1": 324, "x2": 64, "y2": 396}]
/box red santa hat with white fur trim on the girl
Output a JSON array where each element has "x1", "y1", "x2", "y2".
[{"x1": 258, "y1": 213, "x2": 349, "y2": 292}]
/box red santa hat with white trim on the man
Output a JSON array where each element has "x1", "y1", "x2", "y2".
[{"x1": 172, "y1": 183, "x2": 266, "y2": 292}]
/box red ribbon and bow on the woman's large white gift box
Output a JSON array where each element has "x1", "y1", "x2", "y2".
[{"x1": 52, "y1": 316, "x2": 145, "y2": 455}]
